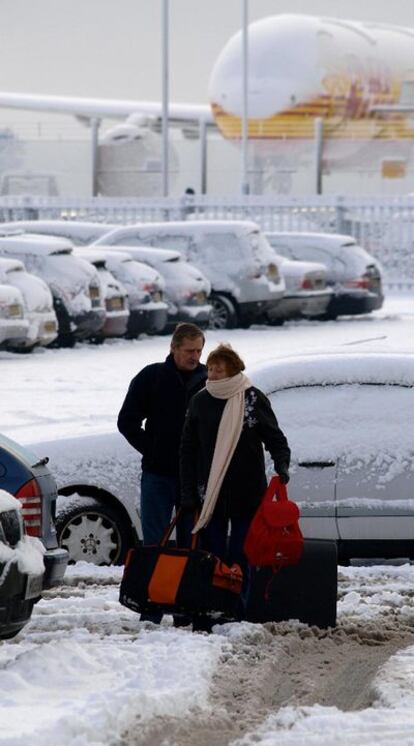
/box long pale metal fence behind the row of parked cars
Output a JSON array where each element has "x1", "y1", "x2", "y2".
[{"x1": 0, "y1": 195, "x2": 414, "y2": 290}]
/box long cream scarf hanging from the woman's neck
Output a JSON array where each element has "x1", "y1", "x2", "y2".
[{"x1": 193, "y1": 373, "x2": 252, "y2": 534}]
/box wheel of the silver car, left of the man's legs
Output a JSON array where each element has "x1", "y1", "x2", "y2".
[{"x1": 56, "y1": 497, "x2": 130, "y2": 565}]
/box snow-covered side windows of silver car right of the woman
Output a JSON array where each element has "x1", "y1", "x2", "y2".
[{"x1": 270, "y1": 384, "x2": 414, "y2": 471}]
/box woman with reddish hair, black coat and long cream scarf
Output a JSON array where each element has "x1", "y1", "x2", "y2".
[{"x1": 180, "y1": 344, "x2": 290, "y2": 620}]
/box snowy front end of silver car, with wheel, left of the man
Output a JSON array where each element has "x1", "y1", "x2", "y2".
[{"x1": 29, "y1": 432, "x2": 142, "y2": 565}]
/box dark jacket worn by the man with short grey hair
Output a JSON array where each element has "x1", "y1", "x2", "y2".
[{"x1": 118, "y1": 354, "x2": 207, "y2": 477}]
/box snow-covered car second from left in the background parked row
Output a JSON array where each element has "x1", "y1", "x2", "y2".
[{"x1": 0, "y1": 257, "x2": 58, "y2": 349}]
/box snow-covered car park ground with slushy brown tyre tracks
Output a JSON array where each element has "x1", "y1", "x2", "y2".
[{"x1": 0, "y1": 297, "x2": 414, "y2": 746}]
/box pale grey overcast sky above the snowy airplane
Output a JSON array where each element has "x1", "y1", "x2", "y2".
[{"x1": 0, "y1": 0, "x2": 414, "y2": 102}]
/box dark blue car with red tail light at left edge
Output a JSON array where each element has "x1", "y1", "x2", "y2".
[{"x1": 0, "y1": 434, "x2": 68, "y2": 589}]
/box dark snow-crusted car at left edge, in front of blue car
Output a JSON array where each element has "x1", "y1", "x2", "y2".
[{"x1": 0, "y1": 489, "x2": 45, "y2": 640}]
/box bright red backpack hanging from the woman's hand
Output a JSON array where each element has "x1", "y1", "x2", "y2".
[{"x1": 244, "y1": 477, "x2": 303, "y2": 570}]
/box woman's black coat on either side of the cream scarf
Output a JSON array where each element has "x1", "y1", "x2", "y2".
[{"x1": 180, "y1": 386, "x2": 290, "y2": 519}]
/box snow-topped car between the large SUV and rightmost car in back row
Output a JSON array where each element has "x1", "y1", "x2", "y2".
[{"x1": 265, "y1": 252, "x2": 333, "y2": 324}]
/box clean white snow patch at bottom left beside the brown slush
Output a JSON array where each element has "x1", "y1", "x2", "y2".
[{"x1": 0, "y1": 629, "x2": 225, "y2": 746}]
